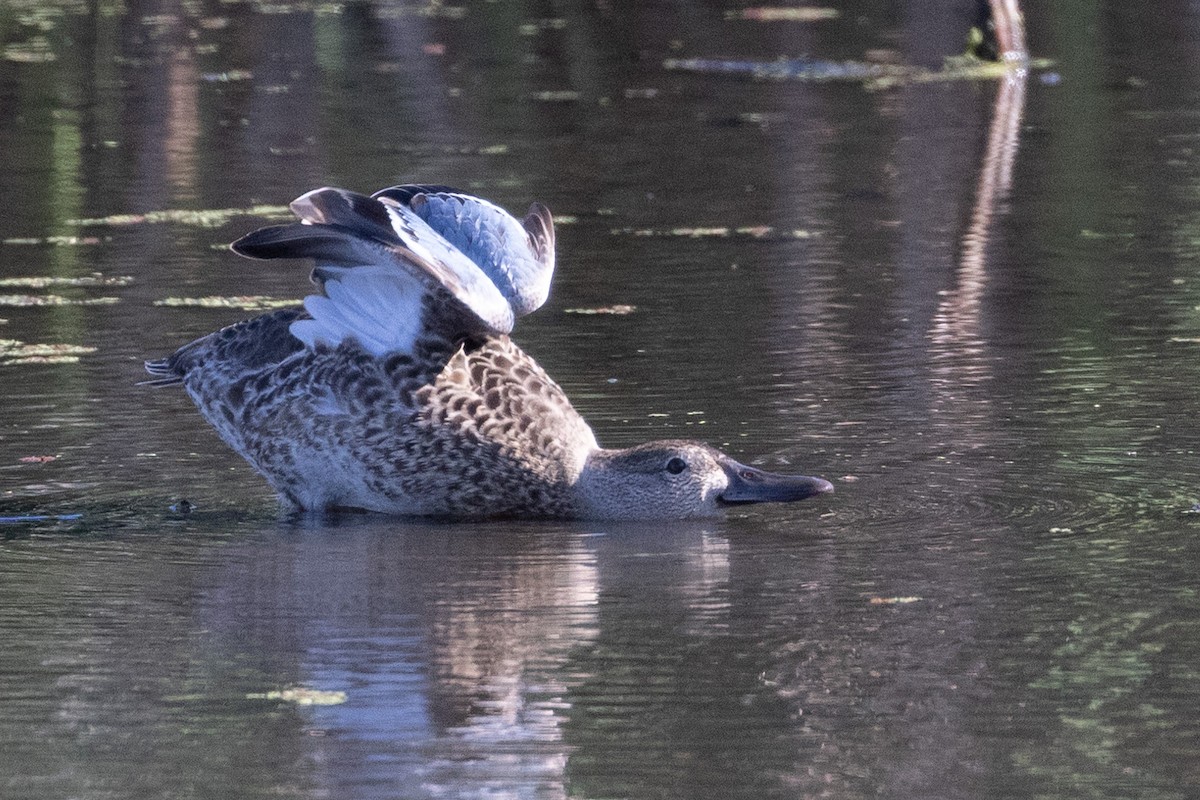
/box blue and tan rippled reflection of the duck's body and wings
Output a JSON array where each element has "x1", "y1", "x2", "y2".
[{"x1": 202, "y1": 523, "x2": 598, "y2": 796}]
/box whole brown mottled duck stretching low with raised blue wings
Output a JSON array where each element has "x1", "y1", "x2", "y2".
[{"x1": 146, "y1": 186, "x2": 833, "y2": 518}]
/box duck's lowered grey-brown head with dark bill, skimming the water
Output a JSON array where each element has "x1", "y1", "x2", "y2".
[{"x1": 576, "y1": 440, "x2": 833, "y2": 519}]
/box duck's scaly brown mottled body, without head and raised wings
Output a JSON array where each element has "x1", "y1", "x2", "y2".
[{"x1": 151, "y1": 309, "x2": 595, "y2": 516}]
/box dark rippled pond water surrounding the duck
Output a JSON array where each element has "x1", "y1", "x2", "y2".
[{"x1": 0, "y1": 0, "x2": 1200, "y2": 799}]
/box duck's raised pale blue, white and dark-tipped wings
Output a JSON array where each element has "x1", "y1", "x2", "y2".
[{"x1": 233, "y1": 187, "x2": 553, "y2": 354}]
